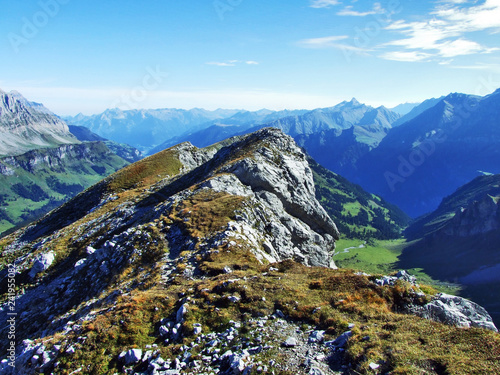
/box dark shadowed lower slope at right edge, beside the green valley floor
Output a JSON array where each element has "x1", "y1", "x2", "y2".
[{"x1": 400, "y1": 175, "x2": 500, "y2": 323}]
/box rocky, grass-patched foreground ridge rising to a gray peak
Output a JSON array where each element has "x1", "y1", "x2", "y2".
[{"x1": 0, "y1": 129, "x2": 500, "y2": 375}]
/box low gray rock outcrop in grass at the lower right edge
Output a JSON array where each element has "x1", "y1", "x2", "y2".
[{"x1": 411, "y1": 293, "x2": 497, "y2": 332}]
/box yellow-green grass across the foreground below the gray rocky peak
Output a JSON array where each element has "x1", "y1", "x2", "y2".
[{"x1": 19, "y1": 247, "x2": 500, "y2": 374}]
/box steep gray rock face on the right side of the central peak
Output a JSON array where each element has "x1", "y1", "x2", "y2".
[{"x1": 216, "y1": 129, "x2": 339, "y2": 267}]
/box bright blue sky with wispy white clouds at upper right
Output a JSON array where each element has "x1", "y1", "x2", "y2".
[{"x1": 0, "y1": 0, "x2": 500, "y2": 115}]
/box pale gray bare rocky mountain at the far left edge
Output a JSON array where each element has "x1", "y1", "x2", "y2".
[{"x1": 0, "y1": 90, "x2": 78, "y2": 156}]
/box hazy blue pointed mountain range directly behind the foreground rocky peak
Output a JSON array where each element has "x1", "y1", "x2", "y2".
[{"x1": 150, "y1": 99, "x2": 400, "y2": 178}]
